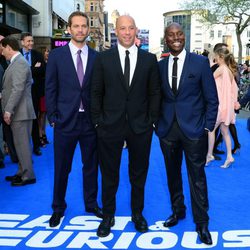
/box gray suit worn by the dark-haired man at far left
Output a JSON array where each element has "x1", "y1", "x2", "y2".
[{"x1": 2, "y1": 54, "x2": 36, "y2": 180}]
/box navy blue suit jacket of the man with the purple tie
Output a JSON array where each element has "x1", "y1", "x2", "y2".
[{"x1": 45, "y1": 45, "x2": 96, "y2": 132}]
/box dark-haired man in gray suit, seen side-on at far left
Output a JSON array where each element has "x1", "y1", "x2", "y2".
[{"x1": 0, "y1": 36, "x2": 36, "y2": 186}]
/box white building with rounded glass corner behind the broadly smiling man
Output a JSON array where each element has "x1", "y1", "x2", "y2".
[{"x1": 163, "y1": 10, "x2": 250, "y2": 61}]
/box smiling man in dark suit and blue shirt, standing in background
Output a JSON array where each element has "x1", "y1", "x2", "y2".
[{"x1": 20, "y1": 32, "x2": 45, "y2": 156}]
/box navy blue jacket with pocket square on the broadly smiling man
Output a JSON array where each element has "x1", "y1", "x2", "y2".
[{"x1": 156, "y1": 52, "x2": 218, "y2": 139}]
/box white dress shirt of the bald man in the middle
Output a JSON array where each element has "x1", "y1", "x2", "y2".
[{"x1": 118, "y1": 43, "x2": 138, "y2": 84}]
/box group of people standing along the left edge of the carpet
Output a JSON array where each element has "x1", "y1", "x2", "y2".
[{"x1": 0, "y1": 32, "x2": 49, "y2": 186}]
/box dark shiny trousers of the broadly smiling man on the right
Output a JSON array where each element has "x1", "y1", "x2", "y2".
[{"x1": 160, "y1": 121, "x2": 209, "y2": 224}]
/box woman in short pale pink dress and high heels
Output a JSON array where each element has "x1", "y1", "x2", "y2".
[{"x1": 206, "y1": 48, "x2": 238, "y2": 168}]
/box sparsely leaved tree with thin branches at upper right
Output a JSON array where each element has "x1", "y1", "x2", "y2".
[{"x1": 182, "y1": 0, "x2": 250, "y2": 63}]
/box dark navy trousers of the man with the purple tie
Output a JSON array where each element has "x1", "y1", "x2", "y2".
[{"x1": 52, "y1": 112, "x2": 98, "y2": 213}]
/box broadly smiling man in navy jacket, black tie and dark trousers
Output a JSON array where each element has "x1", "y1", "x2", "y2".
[{"x1": 157, "y1": 23, "x2": 218, "y2": 245}]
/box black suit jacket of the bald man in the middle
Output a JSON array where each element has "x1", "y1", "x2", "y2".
[{"x1": 91, "y1": 47, "x2": 160, "y2": 136}]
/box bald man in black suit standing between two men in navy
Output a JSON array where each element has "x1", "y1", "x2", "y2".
[{"x1": 91, "y1": 15, "x2": 160, "y2": 237}]
